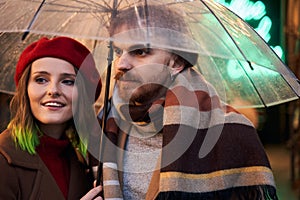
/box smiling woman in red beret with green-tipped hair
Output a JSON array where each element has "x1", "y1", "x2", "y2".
[{"x1": 0, "y1": 37, "x2": 101, "y2": 200}]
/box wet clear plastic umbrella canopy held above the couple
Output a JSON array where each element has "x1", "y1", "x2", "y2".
[{"x1": 0, "y1": 0, "x2": 300, "y2": 107}]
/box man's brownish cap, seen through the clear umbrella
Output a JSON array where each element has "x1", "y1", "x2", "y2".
[{"x1": 109, "y1": 4, "x2": 198, "y2": 67}]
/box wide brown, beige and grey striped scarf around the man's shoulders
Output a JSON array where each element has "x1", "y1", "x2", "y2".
[{"x1": 103, "y1": 68, "x2": 277, "y2": 199}]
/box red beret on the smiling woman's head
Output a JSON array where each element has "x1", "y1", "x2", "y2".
[{"x1": 14, "y1": 37, "x2": 101, "y2": 99}]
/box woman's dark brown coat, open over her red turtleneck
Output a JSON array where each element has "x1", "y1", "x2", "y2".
[{"x1": 0, "y1": 130, "x2": 93, "y2": 200}]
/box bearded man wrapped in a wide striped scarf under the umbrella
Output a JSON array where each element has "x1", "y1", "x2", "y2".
[{"x1": 99, "y1": 5, "x2": 277, "y2": 199}]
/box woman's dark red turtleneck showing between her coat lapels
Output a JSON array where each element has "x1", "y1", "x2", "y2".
[{"x1": 36, "y1": 135, "x2": 70, "y2": 199}]
